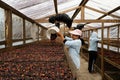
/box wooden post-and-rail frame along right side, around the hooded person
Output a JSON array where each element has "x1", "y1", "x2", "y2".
[{"x1": 83, "y1": 23, "x2": 120, "y2": 80}]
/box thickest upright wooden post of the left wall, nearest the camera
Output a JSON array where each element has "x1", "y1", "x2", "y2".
[{"x1": 5, "y1": 10, "x2": 12, "y2": 48}]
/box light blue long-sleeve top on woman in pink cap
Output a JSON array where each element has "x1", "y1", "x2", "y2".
[{"x1": 65, "y1": 37, "x2": 82, "y2": 69}]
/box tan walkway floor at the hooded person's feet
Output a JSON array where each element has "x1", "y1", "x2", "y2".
[{"x1": 77, "y1": 57, "x2": 102, "y2": 80}]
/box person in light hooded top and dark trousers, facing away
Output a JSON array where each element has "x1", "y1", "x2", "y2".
[{"x1": 88, "y1": 30, "x2": 100, "y2": 73}]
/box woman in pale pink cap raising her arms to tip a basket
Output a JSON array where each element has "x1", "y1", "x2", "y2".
[{"x1": 58, "y1": 29, "x2": 82, "y2": 79}]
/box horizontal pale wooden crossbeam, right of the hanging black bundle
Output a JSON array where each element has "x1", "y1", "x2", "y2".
[{"x1": 73, "y1": 19, "x2": 120, "y2": 23}]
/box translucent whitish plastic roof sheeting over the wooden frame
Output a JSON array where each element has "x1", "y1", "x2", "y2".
[{"x1": 2, "y1": 0, "x2": 120, "y2": 27}]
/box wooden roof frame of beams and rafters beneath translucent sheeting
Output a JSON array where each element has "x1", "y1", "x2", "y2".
[{"x1": 35, "y1": 0, "x2": 120, "y2": 24}]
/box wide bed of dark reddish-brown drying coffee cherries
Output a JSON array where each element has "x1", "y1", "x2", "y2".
[{"x1": 0, "y1": 42, "x2": 73, "y2": 80}]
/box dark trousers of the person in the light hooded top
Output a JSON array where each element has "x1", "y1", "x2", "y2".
[{"x1": 88, "y1": 51, "x2": 98, "y2": 72}]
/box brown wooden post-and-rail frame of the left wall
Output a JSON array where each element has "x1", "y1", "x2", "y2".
[{"x1": 0, "y1": 1, "x2": 47, "y2": 48}]
